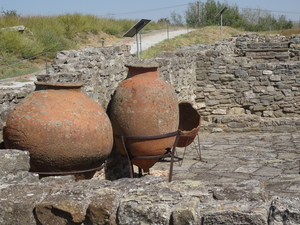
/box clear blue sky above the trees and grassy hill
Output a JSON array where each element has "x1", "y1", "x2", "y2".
[{"x1": 0, "y1": 0, "x2": 300, "y2": 21}]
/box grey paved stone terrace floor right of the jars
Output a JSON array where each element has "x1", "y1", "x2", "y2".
[{"x1": 151, "y1": 133, "x2": 300, "y2": 200}]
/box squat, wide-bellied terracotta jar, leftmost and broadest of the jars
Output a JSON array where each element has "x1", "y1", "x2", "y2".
[{"x1": 3, "y1": 82, "x2": 113, "y2": 176}]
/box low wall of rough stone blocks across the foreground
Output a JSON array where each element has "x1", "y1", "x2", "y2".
[{"x1": 0, "y1": 149, "x2": 300, "y2": 225}]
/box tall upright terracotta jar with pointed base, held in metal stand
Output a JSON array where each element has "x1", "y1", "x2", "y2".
[{"x1": 110, "y1": 64, "x2": 179, "y2": 172}]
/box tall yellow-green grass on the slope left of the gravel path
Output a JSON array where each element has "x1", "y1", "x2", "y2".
[{"x1": 0, "y1": 13, "x2": 171, "y2": 79}]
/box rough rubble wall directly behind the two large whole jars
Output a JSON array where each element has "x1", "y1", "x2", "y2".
[{"x1": 37, "y1": 45, "x2": 196, "y2": 109}]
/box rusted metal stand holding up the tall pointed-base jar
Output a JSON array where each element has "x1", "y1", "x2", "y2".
[{"x1": 114, "y1": 130, "x2": 180, "y2": 182}]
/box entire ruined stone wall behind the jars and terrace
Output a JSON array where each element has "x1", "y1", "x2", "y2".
[{"x1": 0, "y1": 33, "x2": 300, "y2": 139}]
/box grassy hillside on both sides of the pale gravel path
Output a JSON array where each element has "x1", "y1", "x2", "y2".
[{"x1": 0, "y1": 14, "x2": 300, "y2": 79}]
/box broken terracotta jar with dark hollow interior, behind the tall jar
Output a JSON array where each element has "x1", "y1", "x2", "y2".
[{"x1": 177, "y1": 102, "x2": 201, "y2": 147}]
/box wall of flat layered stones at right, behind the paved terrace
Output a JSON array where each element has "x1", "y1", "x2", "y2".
[{"x1": 158, "y1": 34, "x2": 300, "y2": 132}]
